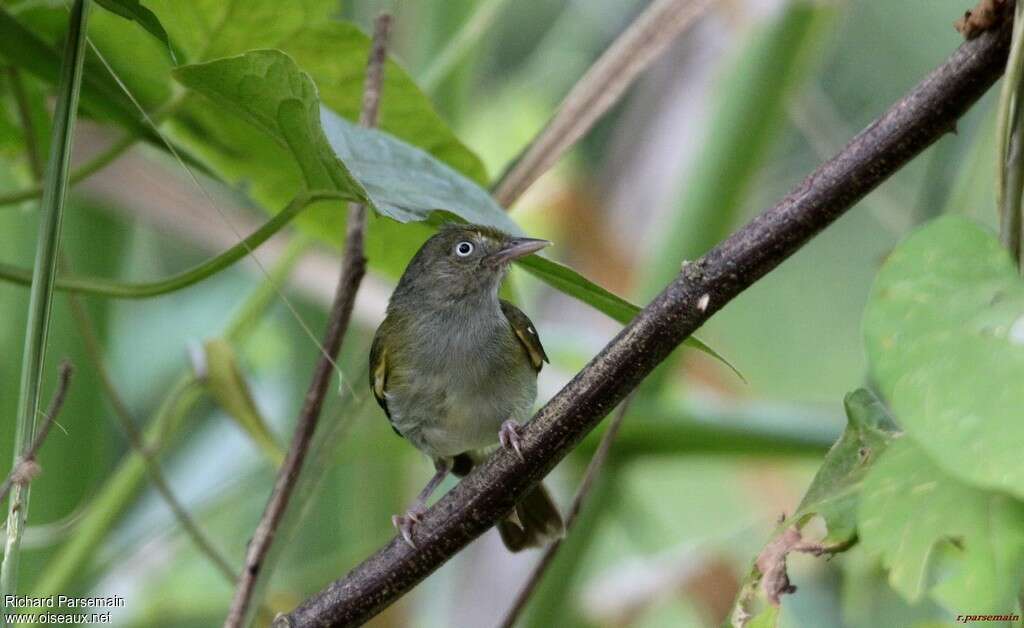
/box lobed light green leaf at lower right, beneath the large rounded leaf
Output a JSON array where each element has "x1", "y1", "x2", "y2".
[{"x1": 858, "y1": 436, "x2": 1024, "y2": 614}]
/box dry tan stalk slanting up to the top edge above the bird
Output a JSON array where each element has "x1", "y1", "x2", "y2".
[{"x1": 494, "y1": 0, "x2": 713, "y2": 207}]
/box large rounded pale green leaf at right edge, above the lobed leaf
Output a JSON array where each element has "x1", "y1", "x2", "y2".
[{"x1": 864, "y1": 216, "x2": 1024, "y2": 496}]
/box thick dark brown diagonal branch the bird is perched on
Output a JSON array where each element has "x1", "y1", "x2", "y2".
[{"x1": 278, "y1": 17, "x2": 1011, "y2": 627}]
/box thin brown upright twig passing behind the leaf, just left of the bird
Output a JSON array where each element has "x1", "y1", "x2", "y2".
[{"x1": 224, "y1": 13, "x2": 391, "y2": 628}]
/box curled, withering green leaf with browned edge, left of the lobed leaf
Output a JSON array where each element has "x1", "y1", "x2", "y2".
[{"x1": 794, "y1": 388, "x2": 894, "y2": 545}]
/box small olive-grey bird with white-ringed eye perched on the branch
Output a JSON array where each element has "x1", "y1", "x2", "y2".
[{"x1": 370, "y1": 224, "x2": 562, "y2": 551}]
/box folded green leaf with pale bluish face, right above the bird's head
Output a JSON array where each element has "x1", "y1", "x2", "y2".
[{"x1": 175, "y1": 50, "x2": 519, "y2": 237}]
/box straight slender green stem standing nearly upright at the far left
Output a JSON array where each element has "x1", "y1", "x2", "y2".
[{"x1": 0, "y1": 0, "x2": 91, "y2": 598}]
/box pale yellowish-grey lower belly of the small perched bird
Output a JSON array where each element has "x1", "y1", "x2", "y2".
[{"x1": 388, "y1": 364, "x2": 537, "y2": 458}]
